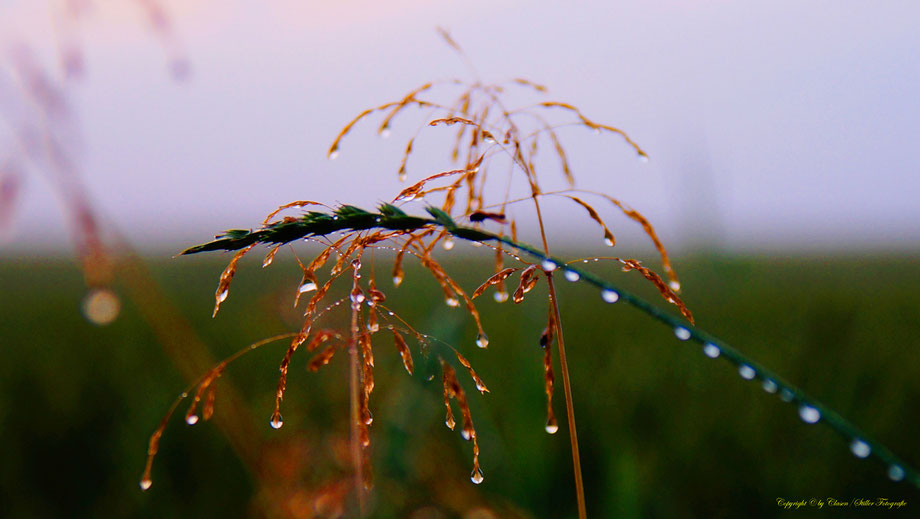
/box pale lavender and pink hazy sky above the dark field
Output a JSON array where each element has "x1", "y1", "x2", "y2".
[{"x1": 0, "y1": 0, "x2": 920, "y2": 251}]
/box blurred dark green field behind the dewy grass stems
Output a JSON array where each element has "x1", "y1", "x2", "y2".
[{"x1": 0, "y1": 254, "x2": 920, "y2": 518}]
